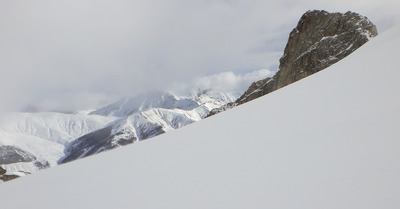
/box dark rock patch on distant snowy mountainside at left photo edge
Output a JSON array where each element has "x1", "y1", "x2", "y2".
[{"x1": 0, "y1": 146, "x2": 36, "y2": 164}]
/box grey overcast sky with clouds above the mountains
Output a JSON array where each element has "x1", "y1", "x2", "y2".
[{"x1": 0, "y1": 0, "x2": 400, "y2": 112}]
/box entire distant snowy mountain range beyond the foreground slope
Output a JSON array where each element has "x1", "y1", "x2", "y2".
[{"x1": 0, "y1": 83, "x2": 266, "y2": 176}]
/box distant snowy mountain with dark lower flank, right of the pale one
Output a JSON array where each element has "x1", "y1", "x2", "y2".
[{"x1": 59, "y1": 91, "x2": 239, "y2": 163}]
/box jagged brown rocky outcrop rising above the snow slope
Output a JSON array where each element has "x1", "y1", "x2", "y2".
[{"x1": 209, "y1": 10, "x2": 378, "y2": 116}]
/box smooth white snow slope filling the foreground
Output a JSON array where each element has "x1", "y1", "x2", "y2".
[{"x1": 0, "y1": 27, "x2": 400, "y2": 209}]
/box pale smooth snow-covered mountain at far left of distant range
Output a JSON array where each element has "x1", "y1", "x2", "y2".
[{"x1": 0, "y1": 112, "x2": 115, "y2": 175}]
